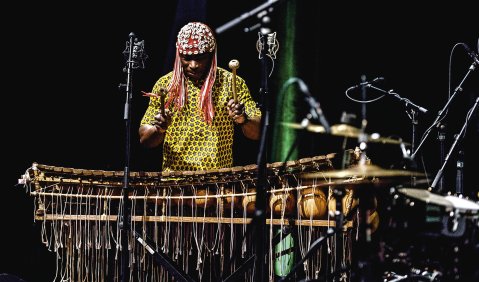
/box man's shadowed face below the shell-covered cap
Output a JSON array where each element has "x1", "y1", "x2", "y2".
[{"x1": 180, "y1": 52, "x2": 213, "y2": 81}]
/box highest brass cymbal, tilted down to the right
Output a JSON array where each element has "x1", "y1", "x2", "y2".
[{"x1": 281, "y1": 122, "x2": 409, "y2": 145}]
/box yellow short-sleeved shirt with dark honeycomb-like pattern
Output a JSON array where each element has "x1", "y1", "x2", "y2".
[{"x1": 141, "y1": 67, "x2": 261, "y2": 171}]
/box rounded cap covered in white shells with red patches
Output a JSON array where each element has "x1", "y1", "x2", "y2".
[{"x1": 176, "y1": 22, "x2": 216, "y2": 55}]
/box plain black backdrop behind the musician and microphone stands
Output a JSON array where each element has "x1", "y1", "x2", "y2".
[{"x1": 0, "y1": 1, "x2": 479, "y2": 281}]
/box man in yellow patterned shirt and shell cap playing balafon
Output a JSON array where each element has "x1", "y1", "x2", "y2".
[{"x1": 139, "y1": 22, "x2": 261, "y2": 171}]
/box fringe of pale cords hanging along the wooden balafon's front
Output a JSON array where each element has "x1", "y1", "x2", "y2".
[{"x1": 35, "y1": 181, "x2": 351, "y2": 282}]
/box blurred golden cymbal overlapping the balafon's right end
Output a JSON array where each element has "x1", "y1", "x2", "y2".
[{"x1": 301, "y1": 165, "x2": 425, "y2": 179}]
